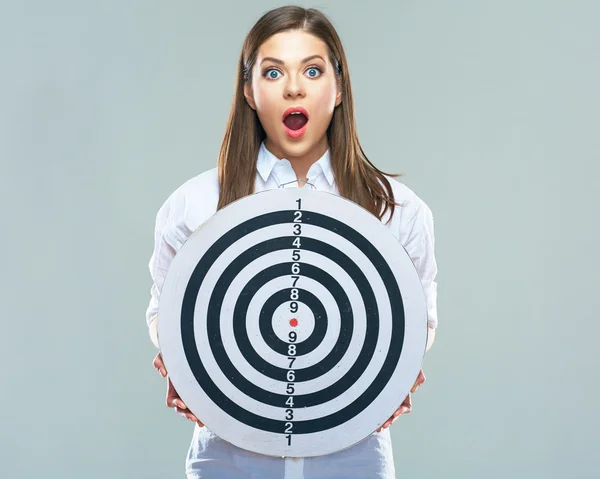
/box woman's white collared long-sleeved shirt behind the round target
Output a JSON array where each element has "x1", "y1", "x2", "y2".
[{"x1": 146, "y1": 143, "x2": 438, "y2": 479}]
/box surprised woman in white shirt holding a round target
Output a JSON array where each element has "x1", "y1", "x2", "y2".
[{"x1": 146, "y1": 6, "x2": 437, "y2": 479}]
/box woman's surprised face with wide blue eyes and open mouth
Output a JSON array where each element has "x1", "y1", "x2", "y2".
[{"x1": 244, "y1": 30, "x2": 342, "y2": 158}]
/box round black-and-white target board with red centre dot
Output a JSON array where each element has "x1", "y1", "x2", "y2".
[{"x1": 158, "y1": 188, "x2": 427, "y2": 457}]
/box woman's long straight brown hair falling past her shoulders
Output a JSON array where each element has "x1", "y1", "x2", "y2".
[{"x1": 217, "y1": 6, "x2": 401, "y2": 220}]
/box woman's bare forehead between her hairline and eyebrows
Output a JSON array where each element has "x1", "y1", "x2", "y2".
[{"x1": 257, "y1": 30, "x2": 328, "y2": 63}]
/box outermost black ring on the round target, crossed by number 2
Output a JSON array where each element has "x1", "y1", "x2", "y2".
[{"x1": 181, "y1": 210, "x2": 404, "y2": 434}]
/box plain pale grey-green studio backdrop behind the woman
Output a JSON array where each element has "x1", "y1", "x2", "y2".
[{"x1": 0, "y1": 0, "x2": 600, "y2": 479}]
